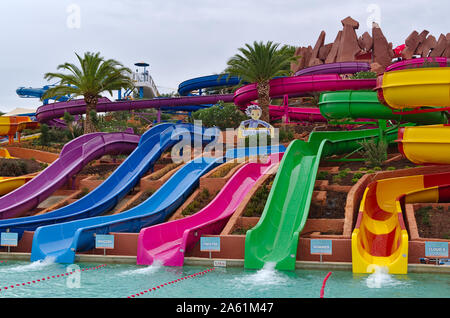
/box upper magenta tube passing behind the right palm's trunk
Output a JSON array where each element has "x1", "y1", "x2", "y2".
[{"x1": 233, "y1": 74, "x2": 376, "y2": 107}]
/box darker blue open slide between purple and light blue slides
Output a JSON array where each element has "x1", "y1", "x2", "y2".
[{"x1": 0, "y1": 123, "x2": 211, "y2": 238}]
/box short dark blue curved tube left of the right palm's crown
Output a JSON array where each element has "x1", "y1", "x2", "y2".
[{"x1": 178, "y1": 74, "x2": 240, "y2": 96}]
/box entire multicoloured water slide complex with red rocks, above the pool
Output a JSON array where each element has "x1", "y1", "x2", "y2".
[{"x1": 0, "y1": 17, "x2": 450, "y2": 298}]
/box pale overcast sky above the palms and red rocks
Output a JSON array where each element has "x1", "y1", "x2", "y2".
[{"x1": 0, "y1": 0, "x2": 450, "y2": 112}]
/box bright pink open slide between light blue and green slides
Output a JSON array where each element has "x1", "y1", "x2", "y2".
[{"x1": 137, "y1": 153, "x2": 283, "y2": 266}]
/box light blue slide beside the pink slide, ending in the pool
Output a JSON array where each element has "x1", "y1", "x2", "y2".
[{"x1": 31, "y1": 145, "x2": 285, "y2": 263}]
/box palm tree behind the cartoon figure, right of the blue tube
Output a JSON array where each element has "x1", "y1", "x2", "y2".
[{"x1": 225, "y1": 41, "x2": 298, "y2": 122}]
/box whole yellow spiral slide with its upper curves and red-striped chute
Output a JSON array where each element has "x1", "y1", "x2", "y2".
[{"x1": 352, "y1": 59, "x2": 450, "y2": 274}]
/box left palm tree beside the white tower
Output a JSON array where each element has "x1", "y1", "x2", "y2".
[{"x1": 41, "y1": 52, "x2": 134, "y2": 134}]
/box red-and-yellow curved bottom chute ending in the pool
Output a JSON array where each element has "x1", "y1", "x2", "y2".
[{"x1": 352, "y1": 173, "x2": 450, "y2": 274}]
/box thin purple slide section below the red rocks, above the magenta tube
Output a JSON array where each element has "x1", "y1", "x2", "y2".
[{"x1": 294, "y1": 62, "x2": 370, "y2": 76}]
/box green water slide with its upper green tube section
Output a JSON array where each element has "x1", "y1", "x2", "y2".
[{"x1": 244, "y1": 91, "x2": 446, "y2": 270}]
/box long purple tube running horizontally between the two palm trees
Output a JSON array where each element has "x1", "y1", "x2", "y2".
[{"x1": 36, "y1": 94, "x2": 233, "y2": 123}]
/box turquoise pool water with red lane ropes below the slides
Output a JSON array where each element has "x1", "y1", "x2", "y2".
[{"x1": 0, "y1": 261, "x2": 450, "y2": 298}]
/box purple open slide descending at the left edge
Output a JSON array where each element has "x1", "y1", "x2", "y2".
[{"x1": 0, "y1": 132, "x2": 140, "y2": 219}]
